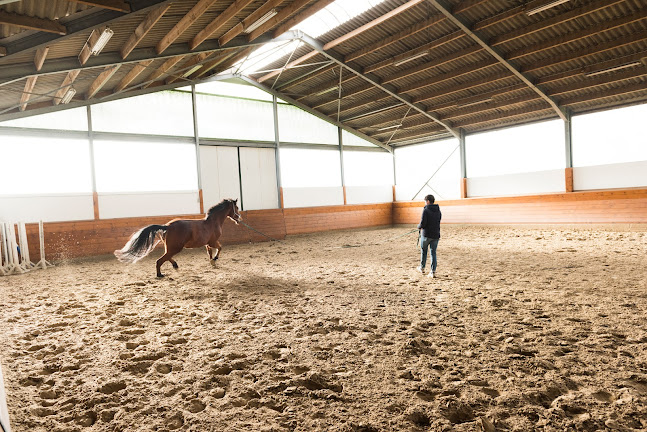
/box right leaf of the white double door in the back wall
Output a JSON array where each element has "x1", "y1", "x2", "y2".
[{"x1": 240, "y1": 147, "x2": 279, "y2": 210}]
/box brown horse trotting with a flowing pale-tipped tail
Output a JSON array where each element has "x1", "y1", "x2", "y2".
[{"x1": 115, "y1": 199, "x2": 243, "y2": 277}]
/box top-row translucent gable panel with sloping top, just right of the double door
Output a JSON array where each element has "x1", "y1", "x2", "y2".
[{"x1": 278, "y1": 105, "x2": 339, "y2": 144}]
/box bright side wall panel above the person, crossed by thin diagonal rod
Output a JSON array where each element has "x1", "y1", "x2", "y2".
[{"x1": 395, "y1": 139, "x2": 461, "y2": 201}]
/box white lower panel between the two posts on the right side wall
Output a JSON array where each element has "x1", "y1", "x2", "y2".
[{"x1": 467, "y1": 169, "x2": 566, "y2": 197}]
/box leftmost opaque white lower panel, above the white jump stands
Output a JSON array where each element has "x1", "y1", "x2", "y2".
[{"x1": 0, "y1": 194, "x2": 94, "y2": 222}]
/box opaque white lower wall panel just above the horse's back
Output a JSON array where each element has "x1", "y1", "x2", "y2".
[{"x1": 99, "y1": 191, "x2": 200, "y2": 219}]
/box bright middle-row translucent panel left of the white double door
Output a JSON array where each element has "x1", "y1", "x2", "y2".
[{"x1": 94, "y1": 139, "x2": 198, "y2": 192}]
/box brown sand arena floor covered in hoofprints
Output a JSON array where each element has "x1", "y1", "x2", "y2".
[{"x1": 0, "y1": 225, "x2": 647, "y2": 432}]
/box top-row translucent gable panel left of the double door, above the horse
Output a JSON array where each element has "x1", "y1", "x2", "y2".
[{"x1": 91, "y1": 91, "x2": 194, "y2": 136}]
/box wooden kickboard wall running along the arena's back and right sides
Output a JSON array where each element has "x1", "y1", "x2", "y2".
[{"x1": 10, "y1": 189, "x2": 647, "y2": 262}]
